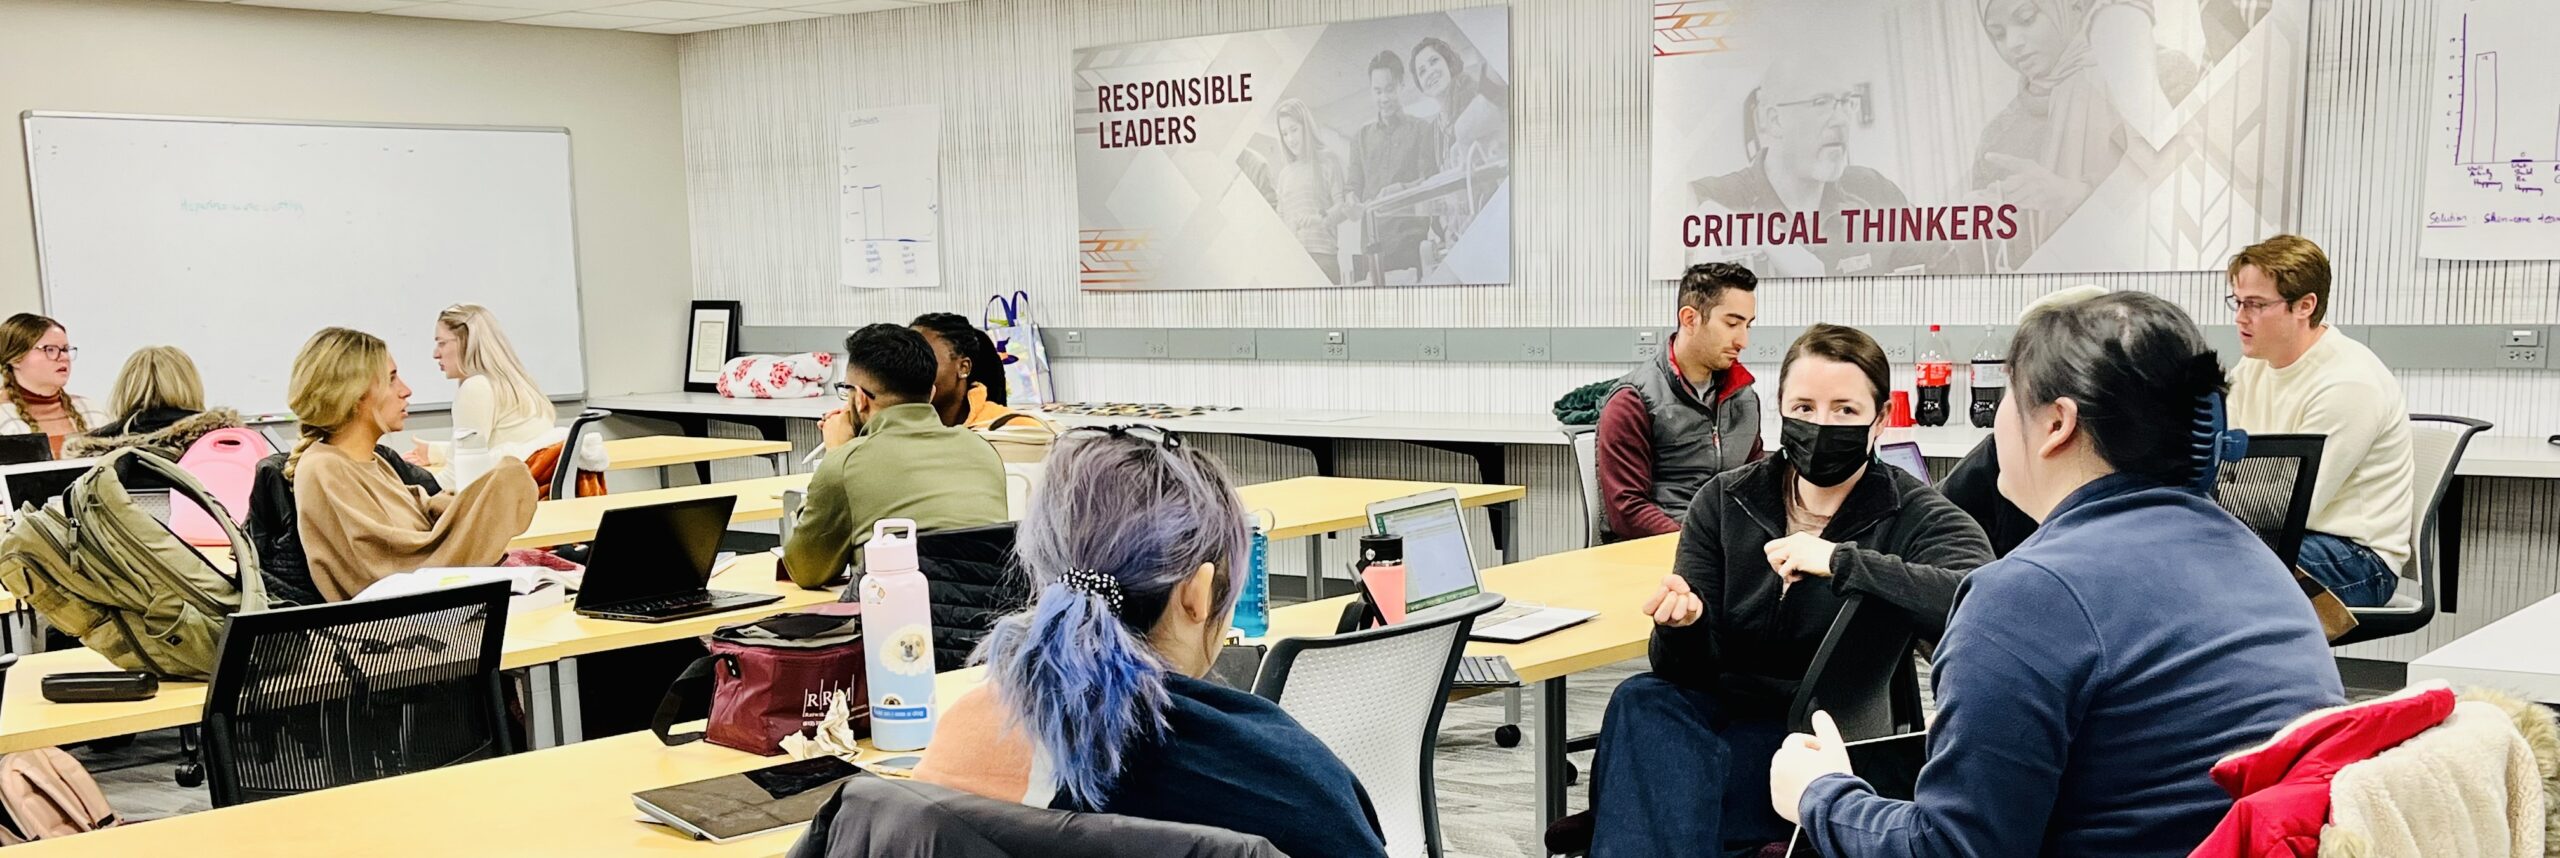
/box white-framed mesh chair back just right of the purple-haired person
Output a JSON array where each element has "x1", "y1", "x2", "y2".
[{"x1": 1254, "y1": 594, "x2": 1503, "y2": 858}]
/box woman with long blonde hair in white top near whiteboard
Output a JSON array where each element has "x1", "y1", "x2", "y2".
[{"x1": 407, "y1": 305, "x2": 566, "y2": 487}]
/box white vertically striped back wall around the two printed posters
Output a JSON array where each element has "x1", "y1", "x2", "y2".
[{"x1": 681, "y1": 0, "x2": 2560, "y2": 658}]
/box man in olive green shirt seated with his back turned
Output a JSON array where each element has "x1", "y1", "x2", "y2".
[{"x1": 783, "y1": 325, "x2": 1006, "y2": 589}]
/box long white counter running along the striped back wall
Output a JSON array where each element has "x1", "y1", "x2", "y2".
[{"x1": 589, "y1": 392, "x2": 2560, "y2": 479}]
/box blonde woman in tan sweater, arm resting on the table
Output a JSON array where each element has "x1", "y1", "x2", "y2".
[{"x1": 284, "y1": 328, "x2": 535, "y2": 602}]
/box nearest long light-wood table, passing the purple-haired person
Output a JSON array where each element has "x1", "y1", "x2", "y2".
[{"x1": 23, "y1": 535, "x2": 1677, "y2": 858}]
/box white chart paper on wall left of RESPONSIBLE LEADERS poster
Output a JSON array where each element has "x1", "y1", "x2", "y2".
[{"x1": 837, "y1": 105, "x2": 942, "y2": 289}]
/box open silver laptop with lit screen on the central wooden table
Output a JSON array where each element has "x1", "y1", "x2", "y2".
[{"x1": 1370, "y1": 489, "x2": 1600, "y2": 643}]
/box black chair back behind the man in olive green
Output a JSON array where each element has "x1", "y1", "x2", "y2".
[{"x1": 906, "y1": 522, "x2": 1032, "y2": 668}]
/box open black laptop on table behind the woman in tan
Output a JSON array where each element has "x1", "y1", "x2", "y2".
[{"x1": 579, "y1": 494, "x2": 783, "y2": 622}]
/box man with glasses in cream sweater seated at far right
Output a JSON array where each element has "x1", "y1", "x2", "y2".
[{"x1": 2227, "y1": 236, "x2": 2417, "y2": 607}]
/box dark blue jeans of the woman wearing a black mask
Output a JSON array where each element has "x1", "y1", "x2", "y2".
[{"x1": 1592, "y1": 674, "x2": 1795, "y2": 858}]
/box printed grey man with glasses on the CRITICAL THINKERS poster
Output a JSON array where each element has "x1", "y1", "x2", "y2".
[{"x1": 1690, "y1": 51, "x2": 1935, "y2": 277}]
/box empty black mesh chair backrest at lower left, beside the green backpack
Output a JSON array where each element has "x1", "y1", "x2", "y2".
[{"x1": 205, "y1": 581, "x2": 515, "y2": 807}]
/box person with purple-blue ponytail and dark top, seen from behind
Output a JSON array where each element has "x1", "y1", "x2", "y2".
[{"x1": 916, "y1": 428, "x2": 1385, "y2": 858}]
